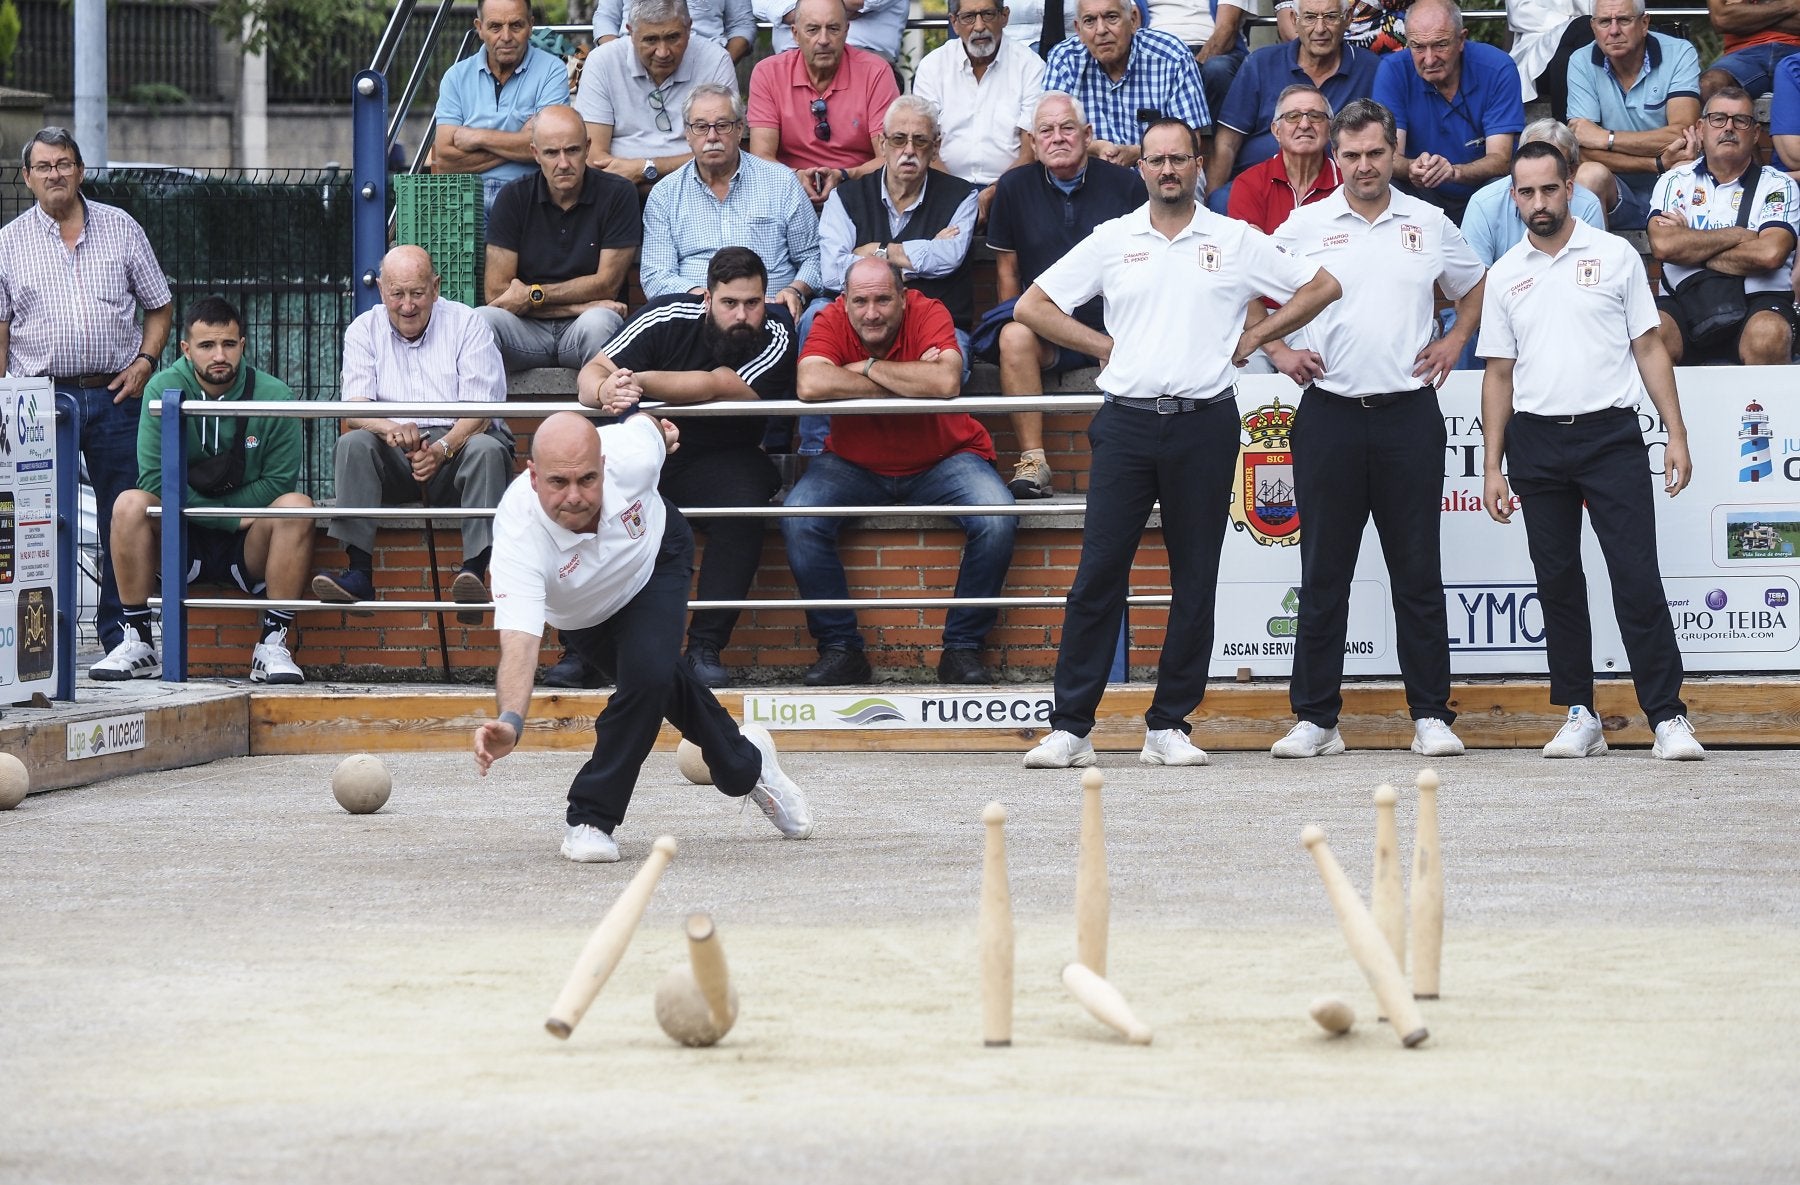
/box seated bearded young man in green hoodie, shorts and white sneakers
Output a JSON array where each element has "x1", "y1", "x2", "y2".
[{"x1": 88, "y1": 295, "x2": 313, "y2": 683}]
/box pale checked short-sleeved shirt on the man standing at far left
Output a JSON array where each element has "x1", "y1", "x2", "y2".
[{"x1": 0, "y1": 202, "x2": 175, "y2": 376}]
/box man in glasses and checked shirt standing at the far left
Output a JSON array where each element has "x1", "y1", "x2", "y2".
[{"x1": 0, "y1": 128, "x2": 175, "y2": 654}]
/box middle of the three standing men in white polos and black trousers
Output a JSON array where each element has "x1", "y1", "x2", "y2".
[{"x1": 1251, "y1": 99, "x2": 1487, "y2": 756}]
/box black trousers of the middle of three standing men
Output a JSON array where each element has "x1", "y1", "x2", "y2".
[{"x1": 1287, "y1": 387, "x2": 1456, "y2": 728}]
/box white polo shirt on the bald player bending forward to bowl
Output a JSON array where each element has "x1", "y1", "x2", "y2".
[{"x1": 488, "y1": 416, "x2": 668, "y2": 636}]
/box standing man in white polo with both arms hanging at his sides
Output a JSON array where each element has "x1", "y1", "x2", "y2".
[{"x1": 1476, "y1": 142, "x2": 1706, "y2": 762}]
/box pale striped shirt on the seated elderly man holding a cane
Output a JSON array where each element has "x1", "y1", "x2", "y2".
[{"x1": 342, "y1": 297, "x2": 506, "y2": 429}]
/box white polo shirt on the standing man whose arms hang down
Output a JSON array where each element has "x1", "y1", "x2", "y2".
[{"x1": 1476, "y1": 216, "x2": 1658, "y2": 416}]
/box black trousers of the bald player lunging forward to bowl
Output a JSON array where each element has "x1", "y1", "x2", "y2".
[{"x1": 562, "y1": 506, "x2": 763, "y2": 834}]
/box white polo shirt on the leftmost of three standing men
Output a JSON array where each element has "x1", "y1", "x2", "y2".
[{"x1": 1037, "y1": 205, "x2": 1319, "y2": 400}]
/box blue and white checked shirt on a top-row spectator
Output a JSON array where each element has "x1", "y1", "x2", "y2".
[{"x1": 1044, "y1": 29, "x2": 1213, "y2": 144}]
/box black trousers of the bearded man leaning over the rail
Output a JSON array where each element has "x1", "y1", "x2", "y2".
[{"x1": 659, "y1": 445, "x2": 781, "y2": 650}]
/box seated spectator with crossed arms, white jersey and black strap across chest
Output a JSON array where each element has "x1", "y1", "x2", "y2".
[{"x1": 1651, "y1": 86, "x2": 1800, "y2": 366}]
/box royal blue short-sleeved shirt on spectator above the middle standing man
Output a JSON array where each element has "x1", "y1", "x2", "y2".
[{"x1": 1373, "y1": 41, "x2": 1525, "y2": 202}]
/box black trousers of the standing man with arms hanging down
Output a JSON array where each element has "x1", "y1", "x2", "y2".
[{"x1": 1507, "y1": 407, "x2": 1687, "y2": 728}]
